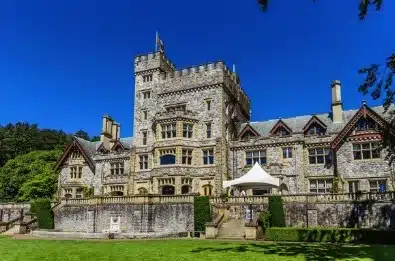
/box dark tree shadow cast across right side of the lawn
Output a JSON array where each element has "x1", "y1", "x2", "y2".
[{"x1": 191, "y1": 243, "x2": 395, "y2": 261}]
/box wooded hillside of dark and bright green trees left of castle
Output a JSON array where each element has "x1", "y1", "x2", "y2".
[{"x1": 0, "y1": 122, "x2": 97, "y2": 202}]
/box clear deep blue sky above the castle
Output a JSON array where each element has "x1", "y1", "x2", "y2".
[{"x1": 0, "y1": 0, "x2": 395, "y2": 136}]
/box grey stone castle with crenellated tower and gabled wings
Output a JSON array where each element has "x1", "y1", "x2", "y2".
[{"x1": 57, "y1": 49, "x2": 392, "y2": 198}]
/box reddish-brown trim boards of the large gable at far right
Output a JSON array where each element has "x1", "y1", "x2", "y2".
[{"x1": 331, "y1": 104, "x2": 388, "y2": 150}]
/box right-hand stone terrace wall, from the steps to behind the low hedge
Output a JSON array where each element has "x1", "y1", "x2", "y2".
[{"x1": 213, "y1": 202, "x2": 395, "y2": 229}]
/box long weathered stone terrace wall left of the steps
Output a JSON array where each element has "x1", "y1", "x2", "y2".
[{"x1": 54, "y1": 204, "x2": 194, "y2": 233}]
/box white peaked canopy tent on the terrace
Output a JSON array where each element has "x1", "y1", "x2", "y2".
[{"x1": 223, "y1": 162, "x2": 280, "y2": 189}]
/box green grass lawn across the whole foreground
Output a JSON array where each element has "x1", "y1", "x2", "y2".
[{"x1": 0, "y1": 237, "x2": 395, "y2": 261}]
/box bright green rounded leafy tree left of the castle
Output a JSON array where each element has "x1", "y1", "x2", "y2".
[{"x1": 0, "y1": 150, "x2": 61, "y2": 201}]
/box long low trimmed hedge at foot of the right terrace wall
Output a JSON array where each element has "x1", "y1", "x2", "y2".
[{"x1": 266, "y1": 227, "x2": 395, "y2": 244}]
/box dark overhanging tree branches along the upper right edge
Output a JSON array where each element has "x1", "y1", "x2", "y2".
[{"x1": 258, "y1": 0, "x2": 395, "y2": 166}]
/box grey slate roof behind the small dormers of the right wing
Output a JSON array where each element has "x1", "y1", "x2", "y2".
[{"x1": 240, "y1": 103, "x2": 395, "y2": 137}]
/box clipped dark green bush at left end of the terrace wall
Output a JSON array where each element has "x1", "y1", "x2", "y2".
[{"x1": 30, "y1": 199, "x2": 54, "y2": 229}]
